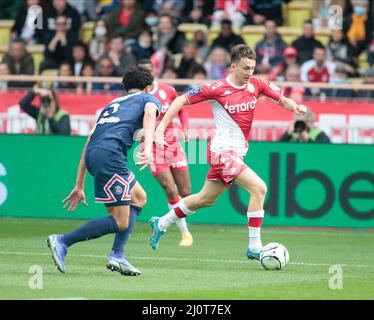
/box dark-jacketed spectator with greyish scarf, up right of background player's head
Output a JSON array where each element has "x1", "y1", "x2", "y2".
[{"x1": 153, "y1": 13, "x2": 185, "y2": 54}]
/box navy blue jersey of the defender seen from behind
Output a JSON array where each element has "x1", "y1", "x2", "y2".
[{"x1": 87, "y1": 91, "x2": 161, "y2": 158}]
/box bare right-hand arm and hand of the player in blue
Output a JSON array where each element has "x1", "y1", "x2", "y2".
[{"x1": 136, "y1": 102, "x2": 157, "y2": 170}]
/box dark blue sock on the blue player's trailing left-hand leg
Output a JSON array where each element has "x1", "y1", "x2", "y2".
[{"x1": 62, "y1": 215, "x2": 119, "y2": 247}]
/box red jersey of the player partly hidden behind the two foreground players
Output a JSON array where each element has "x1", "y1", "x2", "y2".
[{"x1": 150, "y1": 81, "x2": 188, "y2": 142}]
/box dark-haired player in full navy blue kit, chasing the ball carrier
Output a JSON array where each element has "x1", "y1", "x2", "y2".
[{"x1": 47, "y1": 67, "x2": 161, "y2": 276}]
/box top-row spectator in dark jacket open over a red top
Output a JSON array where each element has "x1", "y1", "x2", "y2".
[{"x1": 105, "y1": 0, "x2": 145, "y2": 39}]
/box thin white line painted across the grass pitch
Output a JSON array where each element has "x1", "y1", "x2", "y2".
[{"x1": 0, "y1": 251, "x2": 374, "y2": 268}]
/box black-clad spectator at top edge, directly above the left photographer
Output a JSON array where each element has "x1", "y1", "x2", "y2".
[{"x1": 43, "y1": 0, "x2": 81, "y2": 42}]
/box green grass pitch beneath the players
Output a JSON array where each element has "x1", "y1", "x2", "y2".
[{"x1": 0, "y1": 218, "x2": 374, "y2": 300}]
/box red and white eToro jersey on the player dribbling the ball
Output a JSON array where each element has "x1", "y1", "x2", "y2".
[{"x1": 185, "y1": 77, "x2": 283, "y2": 156}]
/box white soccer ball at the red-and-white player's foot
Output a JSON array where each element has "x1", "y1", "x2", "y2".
[{"x1": 260, "y1": 242, "x2": 290, "y2": 270}]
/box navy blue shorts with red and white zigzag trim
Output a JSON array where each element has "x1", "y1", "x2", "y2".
[{"x1": 85, "y1": 148, "x2": 136, "y2": 207}]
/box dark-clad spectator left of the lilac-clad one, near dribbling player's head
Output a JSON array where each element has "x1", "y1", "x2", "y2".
[{"x1": 174, "y1": 40, "x2": 201, "y2": 79}]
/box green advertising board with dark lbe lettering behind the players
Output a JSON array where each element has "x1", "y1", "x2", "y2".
[{"x1": 0, "y1": 134, "x2": 374, "y2": 228}]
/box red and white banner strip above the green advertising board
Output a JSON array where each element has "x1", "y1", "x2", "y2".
[{"x1": 0, "y1": 92, "x2": 374, "y2": 144}]
